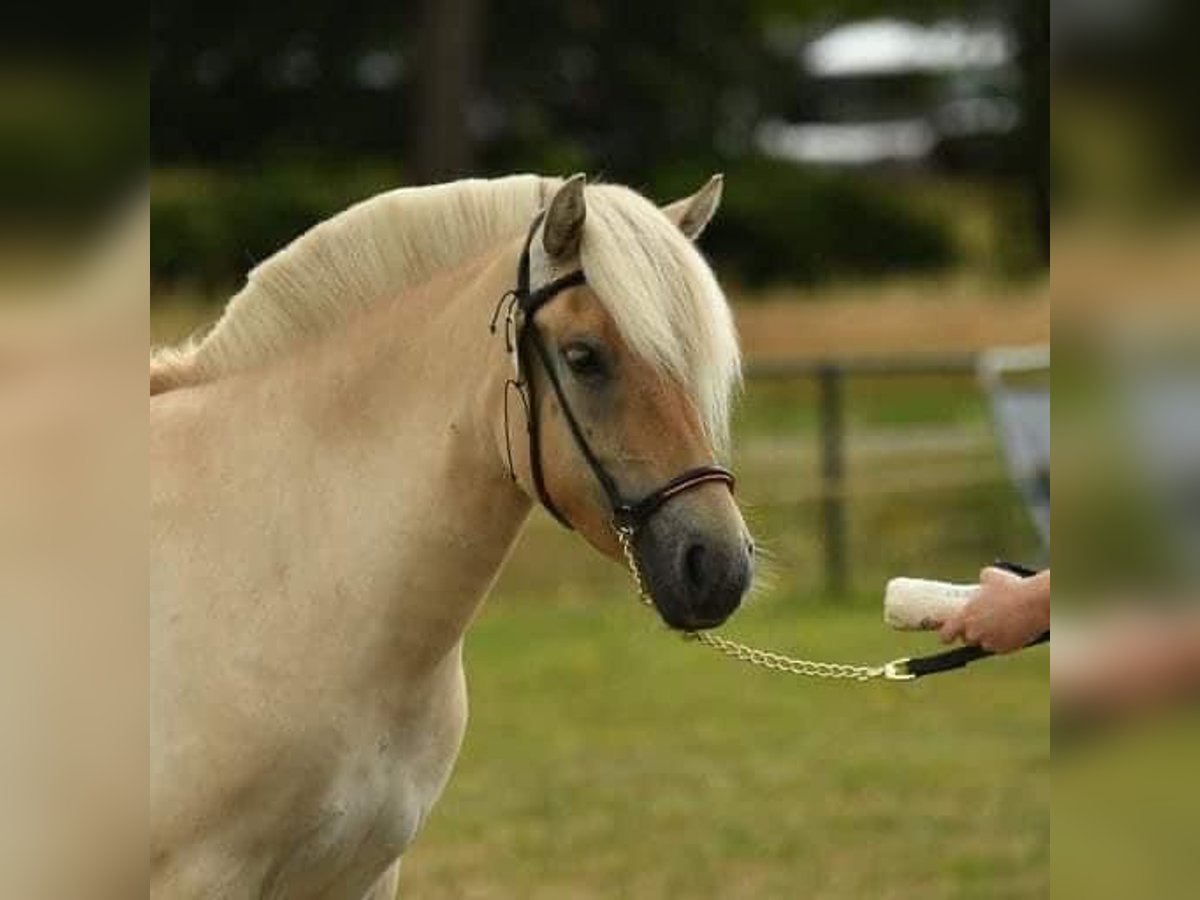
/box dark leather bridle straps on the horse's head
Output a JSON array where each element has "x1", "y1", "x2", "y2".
[{"x1": 491, "y1": 210, "x2": 734, "y2": 535}]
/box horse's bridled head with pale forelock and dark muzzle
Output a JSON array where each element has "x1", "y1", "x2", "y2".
[{"x1": 501, "y1": 175, "x2": 754, "y2": 630}]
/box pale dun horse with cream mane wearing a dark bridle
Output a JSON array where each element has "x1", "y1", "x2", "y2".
[{"x1": 149, "y1": 175, "x2": 754, "y2": 900}]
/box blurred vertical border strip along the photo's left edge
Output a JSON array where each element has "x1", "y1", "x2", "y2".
[{"x1": 0, "y1": 14, "x2": 150, "y2": 900}]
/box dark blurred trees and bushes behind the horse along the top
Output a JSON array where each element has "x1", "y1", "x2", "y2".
[{"x1": 151, "y1": 0, "x2": 1048, "y2": 286}]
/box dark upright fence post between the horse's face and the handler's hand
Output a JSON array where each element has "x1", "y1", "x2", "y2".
[{"x1": 817, "y1": 362, "x2": 848, "y2": 596}]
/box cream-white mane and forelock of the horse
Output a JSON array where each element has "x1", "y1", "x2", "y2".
[{"x1": 150, "y1": 175, "x2": 739, "y2": 445}]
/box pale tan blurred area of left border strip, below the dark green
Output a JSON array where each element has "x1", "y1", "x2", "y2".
[{"x1": 0, "y1": 198, "x2": 149, "y2": 900}]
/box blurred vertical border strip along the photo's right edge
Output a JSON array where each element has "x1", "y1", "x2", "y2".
[{"x1": 1051, "y1": 2, "x2": 1200, "y2": 900}]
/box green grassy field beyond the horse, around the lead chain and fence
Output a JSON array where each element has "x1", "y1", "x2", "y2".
[{"x1": 401, "y1": 412, "x2": 1050, "y2": 900}]
